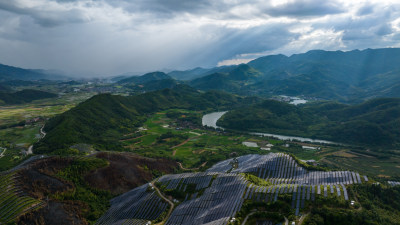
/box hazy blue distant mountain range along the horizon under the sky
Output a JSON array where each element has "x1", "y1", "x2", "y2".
[{"x1": 0, "y1": 48, "x2": 400, "y2": 103}]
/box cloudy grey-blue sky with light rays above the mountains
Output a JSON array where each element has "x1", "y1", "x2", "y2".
[{"x1": 0, "y1": 0, "x2": 400, "y2": 76}]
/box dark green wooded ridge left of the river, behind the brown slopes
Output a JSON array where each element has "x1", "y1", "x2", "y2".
[{"x1": 34, "y1": 85, "x2": 257, "y2": 154}]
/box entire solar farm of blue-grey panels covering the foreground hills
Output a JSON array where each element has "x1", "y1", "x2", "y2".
[{"x1": 98, "y1": 153, "x2": 368, "y2": 225}]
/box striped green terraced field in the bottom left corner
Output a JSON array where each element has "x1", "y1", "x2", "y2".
[{"x1": 0, "y1": 173, "x2": 42, "y2": 224}]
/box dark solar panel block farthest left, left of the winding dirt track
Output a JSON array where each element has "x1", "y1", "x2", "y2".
[{"x1": 96, "y1": 184, "x2": 168, "y2": 225}]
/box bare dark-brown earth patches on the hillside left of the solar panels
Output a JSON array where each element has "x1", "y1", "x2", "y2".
[{"x1": 17, "y1": 152, "x2": 178, "y2": 224}]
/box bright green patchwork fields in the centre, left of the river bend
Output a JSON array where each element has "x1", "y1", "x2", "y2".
[{"x1": 121, "y1": 110, "x2": 263, "y2": 168}]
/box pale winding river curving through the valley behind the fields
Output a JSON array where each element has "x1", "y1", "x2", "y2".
[{"x1": 202, "y1": 111, "x2": 338, "y2": 144}]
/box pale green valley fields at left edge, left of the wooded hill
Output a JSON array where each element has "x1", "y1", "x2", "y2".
[{"x1": 0, "y1": 93, "x2": 93, "y2": 171}]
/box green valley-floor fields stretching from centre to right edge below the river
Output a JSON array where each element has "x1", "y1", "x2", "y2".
[{"x1": 121, "y1": 109, "x2": 400, "y2": 178}]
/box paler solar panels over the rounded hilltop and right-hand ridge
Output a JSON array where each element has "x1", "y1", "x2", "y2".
[{"x1": 208, "y1": 153, "x2": 368, "y2": 215}]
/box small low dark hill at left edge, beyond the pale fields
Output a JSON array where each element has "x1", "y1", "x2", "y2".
[{"x1": 0, "y1": 89, "x2": 57, "y2": 105}]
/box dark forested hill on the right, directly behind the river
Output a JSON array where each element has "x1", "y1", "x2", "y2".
[{"x1": 218, "y1": 98, "x2": 400, "y2": 146}]
